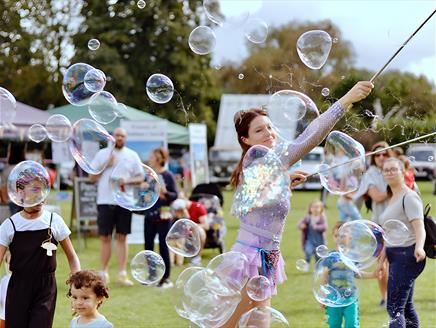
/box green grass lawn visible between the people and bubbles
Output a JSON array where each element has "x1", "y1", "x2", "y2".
[{"x1": 50, "y1": 182, "x2": 436, "y2": 328}]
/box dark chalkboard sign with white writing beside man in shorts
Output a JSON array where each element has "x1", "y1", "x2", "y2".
[{"x1": 74, "y1": 178, "x2": 97, "y2": 221}]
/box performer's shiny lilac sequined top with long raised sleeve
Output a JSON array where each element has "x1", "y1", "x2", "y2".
[{"x1": 231, "y1": 102, "x2": 345, "y2": 250}]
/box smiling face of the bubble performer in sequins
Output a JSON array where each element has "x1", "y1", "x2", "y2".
[{"x1": 242, "y1": 115, "x2": 277, "y2": 148}]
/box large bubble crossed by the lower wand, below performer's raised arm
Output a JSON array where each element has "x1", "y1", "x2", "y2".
[{"x1": 319, "y1": 131, "x2": 366, "y2": 195}]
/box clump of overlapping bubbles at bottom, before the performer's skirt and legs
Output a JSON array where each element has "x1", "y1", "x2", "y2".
[{"x1": 174, "y1": 252, "x2": 289, "y2": 327}]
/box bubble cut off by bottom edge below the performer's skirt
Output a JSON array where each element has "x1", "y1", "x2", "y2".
[{"x1": 238, "y1": 306, "x2": 289, "y2": 328}]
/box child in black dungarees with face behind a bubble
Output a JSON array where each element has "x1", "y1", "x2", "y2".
[{"x1": 0, "y1": 168, "x2": 80, "y2": 327}]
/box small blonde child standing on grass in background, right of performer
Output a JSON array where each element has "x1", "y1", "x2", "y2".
[{"x1": 297, "y1": 200, "x2": 327, "y2": 271}]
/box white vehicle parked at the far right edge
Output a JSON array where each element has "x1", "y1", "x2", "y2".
[{"x1": 406, "y1": 144, "x2": 436, "y2": 180}]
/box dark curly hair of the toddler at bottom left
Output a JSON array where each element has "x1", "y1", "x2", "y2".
[{"x1": 66, "y1": 270, "x2": 109, "y2": 307}]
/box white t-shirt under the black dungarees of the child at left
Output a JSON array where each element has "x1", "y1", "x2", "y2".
[{"x1": 0, "y1": 210, "x2": 71, "y2": 247}]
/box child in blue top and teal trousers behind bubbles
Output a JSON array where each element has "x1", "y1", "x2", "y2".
[{"x1": 325, "y1": 221, "x2": 377, "y2": 328}]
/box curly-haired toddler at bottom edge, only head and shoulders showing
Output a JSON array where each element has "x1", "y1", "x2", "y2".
[{"x1": 67, "y1": 270, "x2": 113, "y2": 328}]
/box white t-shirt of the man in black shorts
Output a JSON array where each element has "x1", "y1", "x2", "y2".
[{"x1": 92, "y1": 147, "x2": 143, "y2": 205}]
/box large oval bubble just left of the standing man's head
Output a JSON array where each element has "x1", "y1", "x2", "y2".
[{"x1": 68, "y1": 118, "x2": 115, "y2": 174}]
